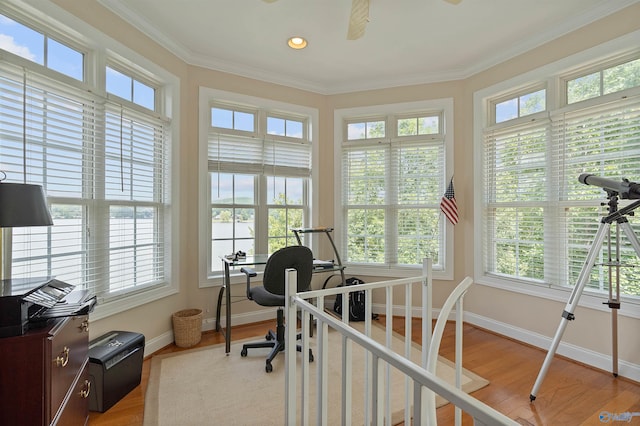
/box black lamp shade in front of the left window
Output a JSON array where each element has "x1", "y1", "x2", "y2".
[{"x1": 0, "y1": 183, "x2": 53, "y2": 228}]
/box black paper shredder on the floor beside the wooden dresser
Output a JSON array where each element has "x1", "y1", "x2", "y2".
[{"x1": 89, "y1": 331, "x2": 144, "y2": 413}]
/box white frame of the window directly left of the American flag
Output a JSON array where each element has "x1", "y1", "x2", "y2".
[{"x1": 333, "y1": 98, "x2": 452, "y2": 280}]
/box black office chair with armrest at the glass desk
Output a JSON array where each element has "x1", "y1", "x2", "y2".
[{"x1": 240, "y1": 246, "x2": 313, "y2": 373}]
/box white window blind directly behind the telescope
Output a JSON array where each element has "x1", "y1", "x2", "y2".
[{"x1": 551, "y1": 96, "x2": 640, "y2": 296}]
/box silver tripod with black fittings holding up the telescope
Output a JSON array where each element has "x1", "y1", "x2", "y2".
[{"x1": 529, "y1": 195, "x2": 640, "y2": 402}]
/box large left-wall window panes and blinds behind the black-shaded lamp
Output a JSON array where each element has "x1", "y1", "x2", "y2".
[{"x1": 0, "y1": 5, "x2": 172, "y2": 310}]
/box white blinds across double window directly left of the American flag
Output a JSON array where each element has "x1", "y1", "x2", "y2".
[{"x1": 342, "y1": 138, "x2": 445, "y2": 268}]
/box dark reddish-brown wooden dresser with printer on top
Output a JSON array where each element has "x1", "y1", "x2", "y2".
[{"x1": 0, "y1": 315, "x2": 91, "y2": 426}]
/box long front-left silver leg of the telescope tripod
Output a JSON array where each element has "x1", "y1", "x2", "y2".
[{"x1": 529, "y1": 222, "x2": 610, "y2": 402}]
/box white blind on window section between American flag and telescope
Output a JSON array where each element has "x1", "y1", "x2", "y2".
[{"x1": 483, "y1": 119, "x2": 549, "y2": 281}]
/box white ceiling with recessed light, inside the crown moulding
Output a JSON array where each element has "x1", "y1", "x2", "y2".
[{"x1": 98, "y1": 0, "x2": 640, "y2": 94}]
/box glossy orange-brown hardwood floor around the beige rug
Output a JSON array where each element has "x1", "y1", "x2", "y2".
[{"x1": 89, "y1": 318, "x2": 640, "y2": 426}]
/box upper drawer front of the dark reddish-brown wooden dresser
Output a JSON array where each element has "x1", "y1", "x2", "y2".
[{"x1": 49, "y1": 315, "x2": 89, "y2": 419}]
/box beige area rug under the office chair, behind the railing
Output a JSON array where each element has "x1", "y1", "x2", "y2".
[{"x1": 144, "y1": 326, "x2": 489, "y2": 426}]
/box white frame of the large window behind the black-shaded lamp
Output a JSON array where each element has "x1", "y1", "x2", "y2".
[{"x1": 0, "y1": 1, "x2": 180, "y2": 320}]
